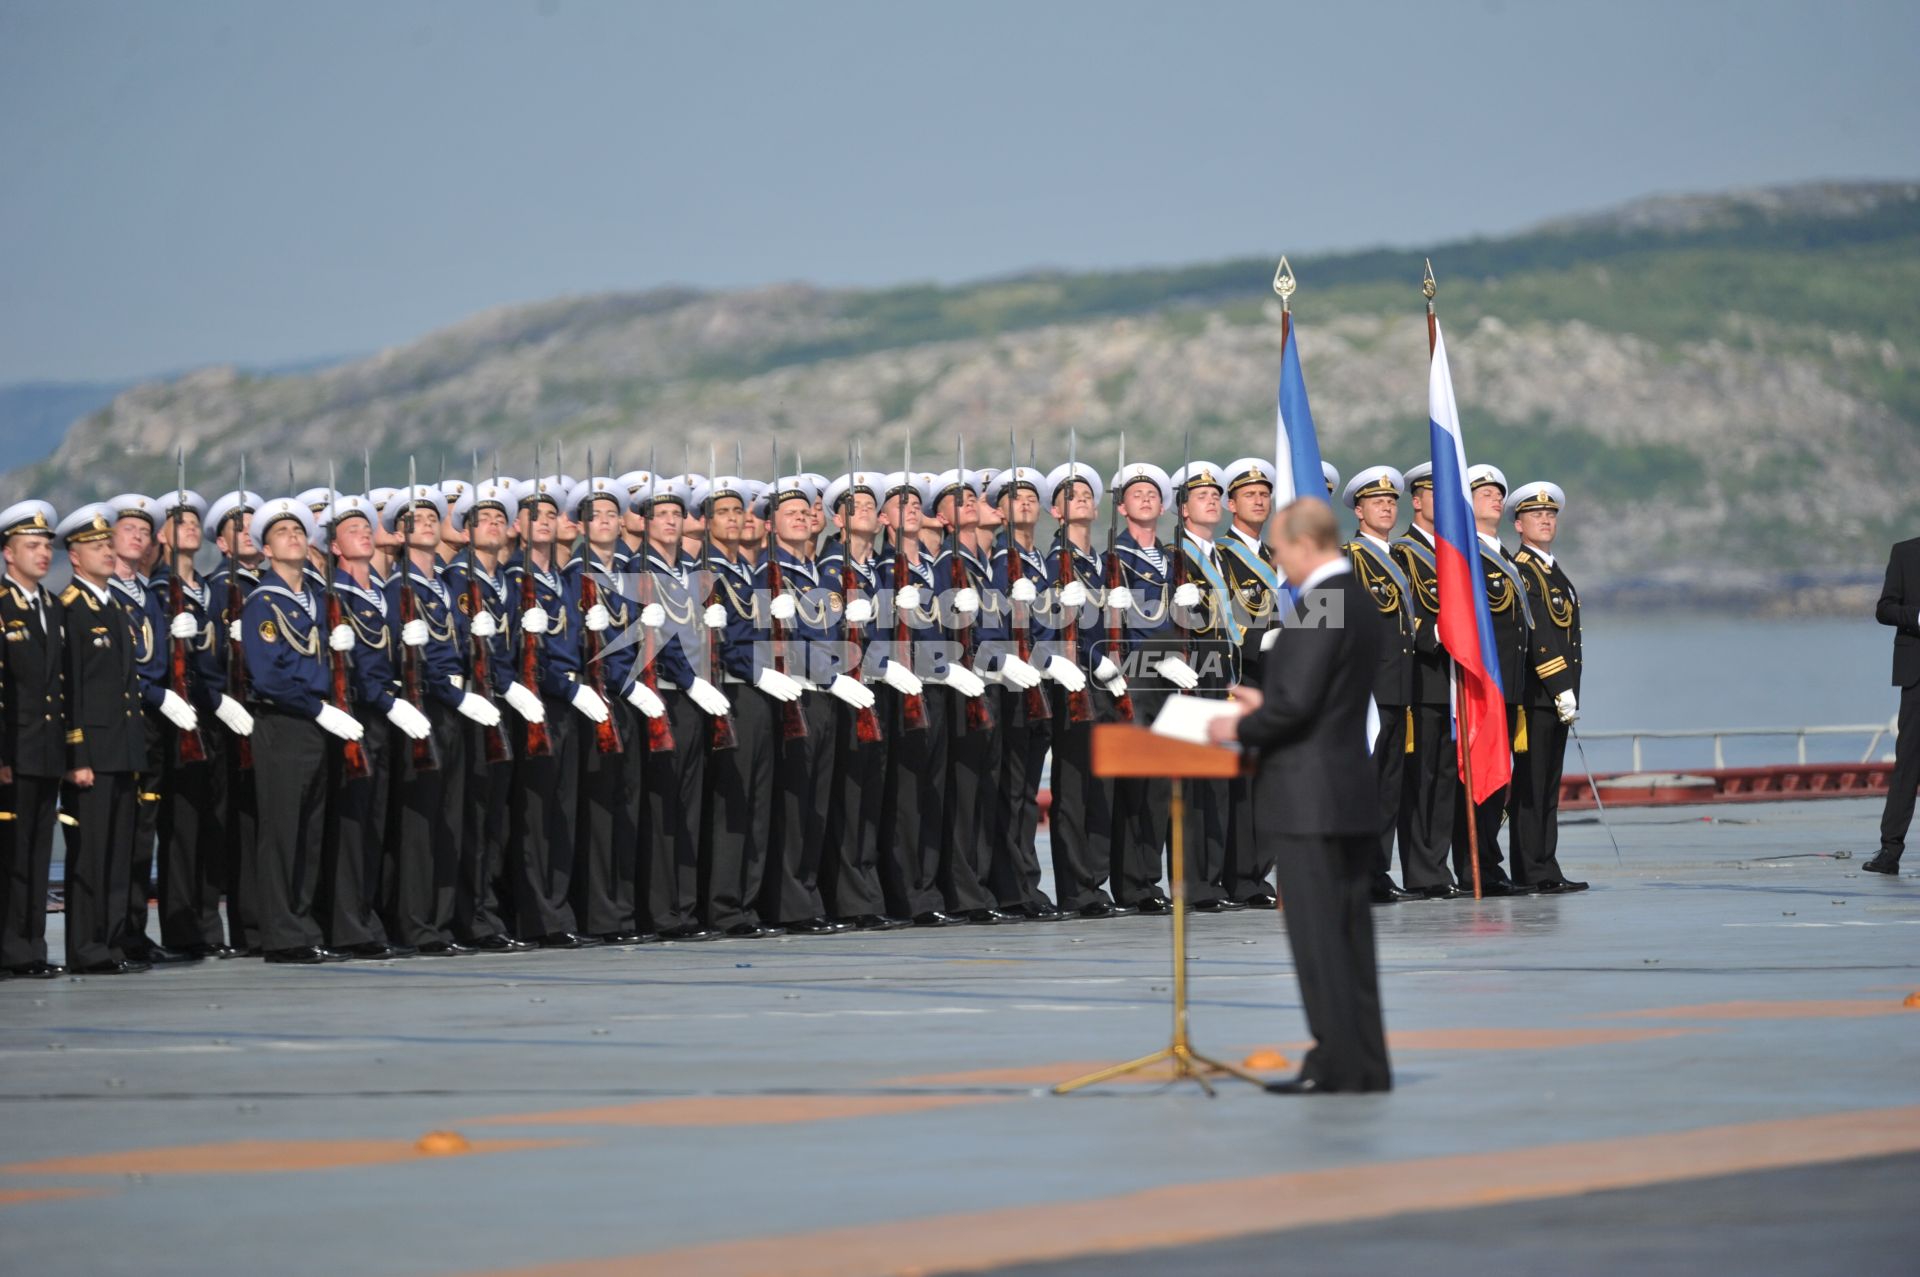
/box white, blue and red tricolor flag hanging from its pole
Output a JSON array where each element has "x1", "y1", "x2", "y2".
[{"x1": 1427, "y1": 321, "x2": 1513, "y2": 803}]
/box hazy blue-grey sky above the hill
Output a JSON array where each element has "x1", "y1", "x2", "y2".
[{"x1": 0, "y1": 0, "x2": 1920, "y2": 382}]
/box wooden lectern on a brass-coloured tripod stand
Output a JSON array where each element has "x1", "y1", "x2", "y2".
[{"x1": 1054, "y1": 722, "x2": 1265, "y2": 1095}]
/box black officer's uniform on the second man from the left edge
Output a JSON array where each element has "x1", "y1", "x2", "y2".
[{"x1": 60, "y1": 584, "x2": 148, "y2": 970}]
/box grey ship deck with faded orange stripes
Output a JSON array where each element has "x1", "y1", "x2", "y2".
[{"x1": 0, "y1": 799, "x2": 1920, "y2": 1277}]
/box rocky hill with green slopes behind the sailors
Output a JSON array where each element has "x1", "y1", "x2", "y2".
[{"x1": 8, "y1": 184, "x2": 1920, "y2": 603}]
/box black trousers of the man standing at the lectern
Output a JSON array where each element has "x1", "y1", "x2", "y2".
[{"x1": 1273, "y1": 833, "x2": 1392, "y2": 1089}]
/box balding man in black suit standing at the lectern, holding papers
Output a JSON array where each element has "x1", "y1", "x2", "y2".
[{"x1": 1210, "y1": 497, "x2": 1394, "y2": 1095}]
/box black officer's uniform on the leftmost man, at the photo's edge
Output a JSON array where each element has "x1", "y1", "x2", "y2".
[{"x1": 0, "y1": 578, "x2": 67, "y2": 970}]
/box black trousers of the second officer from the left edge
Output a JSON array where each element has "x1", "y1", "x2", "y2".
[{"x1": 60, "y1": 772, "x2": 138, "y2": 970}]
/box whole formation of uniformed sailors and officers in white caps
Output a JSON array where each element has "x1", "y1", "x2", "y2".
[{"x1": 0, "y1": 443, "x2": 1584, "y2": 977}]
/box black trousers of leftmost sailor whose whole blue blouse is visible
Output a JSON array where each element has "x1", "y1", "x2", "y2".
[{"x1": 252, "y1": 707, "x2": 326, "y2": 952}]
